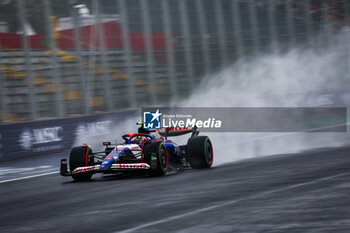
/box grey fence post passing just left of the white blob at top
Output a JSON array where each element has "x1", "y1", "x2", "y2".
[{"x1": 69, "y1": 0, "x2": 90, "y2": 114}]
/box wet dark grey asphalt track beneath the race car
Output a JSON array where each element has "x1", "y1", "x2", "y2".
[{"x1": 0, "y1": 147, "x2": 350, "y2": 233}]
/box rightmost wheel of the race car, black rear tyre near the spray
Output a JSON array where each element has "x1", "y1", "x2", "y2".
[{"x1": 187, "y1": 136, "x2": 214, "y2": 169}]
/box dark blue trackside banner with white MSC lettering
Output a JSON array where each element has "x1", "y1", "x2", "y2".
[{"x1": 0, "y1": 110, "x2": 139, "y2": 161}]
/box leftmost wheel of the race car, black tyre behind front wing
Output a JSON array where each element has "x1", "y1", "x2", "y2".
[{"x1": 69, "y1": 146, "x2": 93, "y2": 181}]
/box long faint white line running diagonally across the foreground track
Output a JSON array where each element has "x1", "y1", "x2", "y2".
[{"x1": 116, "y1": 173, "x2": 350, "y2": 233}]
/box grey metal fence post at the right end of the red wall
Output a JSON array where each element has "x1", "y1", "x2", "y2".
[{"x1": 161, "y1": 0, "x2": 179, "y2": 98}]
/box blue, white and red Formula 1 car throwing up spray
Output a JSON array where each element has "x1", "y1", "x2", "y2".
[{"x1": 60, "y1": 122, "x2": 214, "y2": 181}]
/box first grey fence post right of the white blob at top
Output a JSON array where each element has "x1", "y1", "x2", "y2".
[{"x1": 93, "y1": 0, "x2": 114, "y2": 112}]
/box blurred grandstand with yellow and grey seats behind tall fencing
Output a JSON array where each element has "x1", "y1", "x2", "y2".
[{"x1": 0, "y1": 0, "x2": 350, "y2": 123}]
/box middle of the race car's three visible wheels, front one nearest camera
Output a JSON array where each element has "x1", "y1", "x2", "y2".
[{"x1": 142, "y1": 142, "x2": 169, "y2": 176}]
